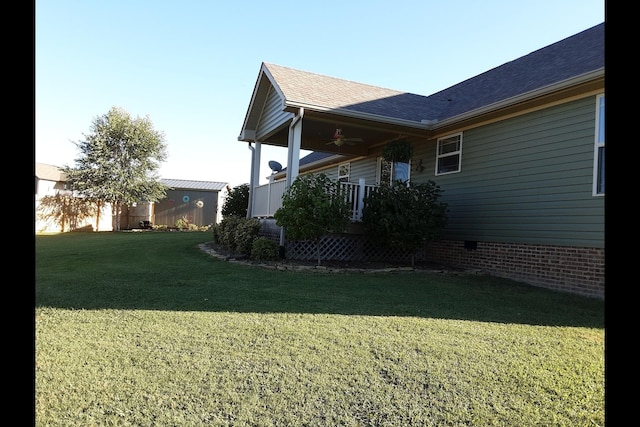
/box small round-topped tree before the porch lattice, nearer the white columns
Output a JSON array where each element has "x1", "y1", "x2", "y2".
[{"x1": 273, "y1": 173, "x2": 350, "y2": 265}]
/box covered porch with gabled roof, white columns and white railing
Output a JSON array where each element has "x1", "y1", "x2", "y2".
[{"x1": 238, "y1": 63, "x2": 434, "y2": 222}]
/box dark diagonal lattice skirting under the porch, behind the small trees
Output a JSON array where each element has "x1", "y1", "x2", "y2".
[{"x1": 285, "y1": 234, "x2": 424, "y2": 262}]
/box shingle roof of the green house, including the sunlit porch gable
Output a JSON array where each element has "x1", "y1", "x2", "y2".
[{"x1": 263, "y1": 23, "x2": 604, "y2": 123}]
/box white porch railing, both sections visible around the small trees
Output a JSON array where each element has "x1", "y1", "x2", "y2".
[{"x1": 252, "y1": 178, "x2": 378, "y2": 221}]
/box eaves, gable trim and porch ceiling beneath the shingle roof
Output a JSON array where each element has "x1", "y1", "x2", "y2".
[{"x1": 238, "y1": 66, "x2": 604, "y2": 156}]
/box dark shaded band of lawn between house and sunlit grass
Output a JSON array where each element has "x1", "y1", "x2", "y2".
[{"x1": 35, "y1": 232, "x2": 604, "y2": 328}]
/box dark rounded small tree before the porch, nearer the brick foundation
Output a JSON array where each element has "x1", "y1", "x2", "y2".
[{"x1": 362, "y1": 180, "x2": 447, "y2": 267}]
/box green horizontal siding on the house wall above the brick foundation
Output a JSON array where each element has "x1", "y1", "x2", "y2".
[{"x1": 428, "y1": 96, "x2": 604, "y2": 248}]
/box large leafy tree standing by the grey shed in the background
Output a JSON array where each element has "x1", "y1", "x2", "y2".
[{"x1": 62, "y1": 107, "x2": 167, "y2": 231}]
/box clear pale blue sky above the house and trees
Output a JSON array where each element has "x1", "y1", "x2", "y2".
[{"x1": 35, "y1": 0, "x2": 605, "y2": 186}]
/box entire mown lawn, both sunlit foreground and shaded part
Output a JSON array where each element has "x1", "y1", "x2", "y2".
[{"x1": 35, "y1": 232, "x2": 605, "y2": 426}]
